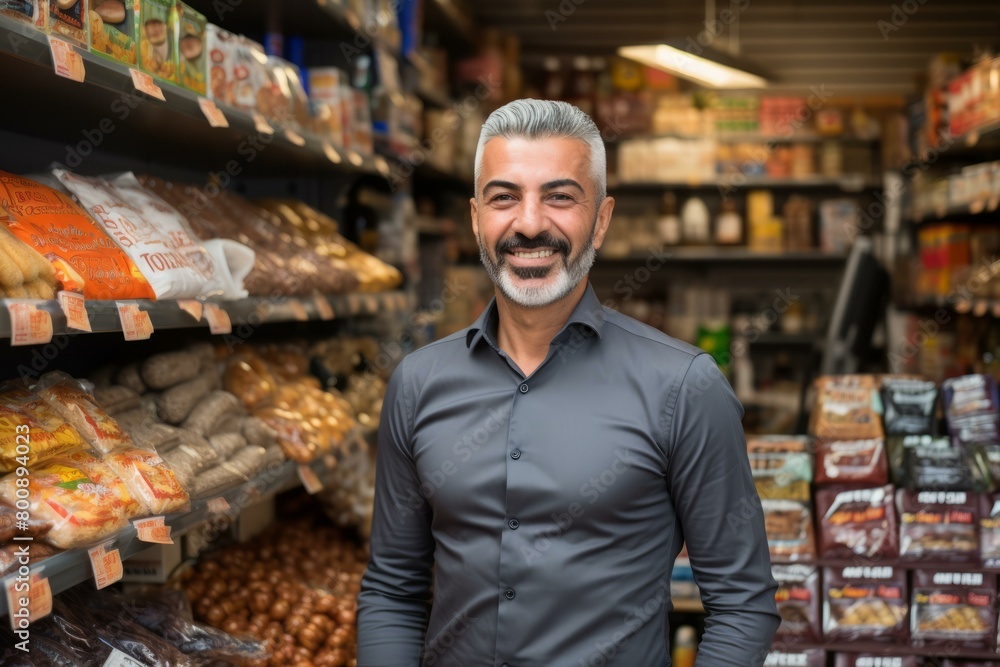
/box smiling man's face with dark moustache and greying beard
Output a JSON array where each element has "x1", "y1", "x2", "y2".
[{"x1": 471, "y1": 138, "x2": 614, "y2": 308}]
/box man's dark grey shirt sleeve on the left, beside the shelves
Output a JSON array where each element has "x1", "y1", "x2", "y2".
[{"x1": 358, "y1": 362, "x2": 434, "y2": 667}]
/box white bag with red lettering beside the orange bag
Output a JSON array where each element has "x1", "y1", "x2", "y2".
[{"x1": 52, "y1": 169, "x2": 213, "y2": 299}]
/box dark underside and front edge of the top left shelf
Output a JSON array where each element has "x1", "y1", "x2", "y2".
[{"x1": 0, "y1": 16, "x2": 388, "y2": 176}]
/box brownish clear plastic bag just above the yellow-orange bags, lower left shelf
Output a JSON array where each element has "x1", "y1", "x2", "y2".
[{"x1": 32, "y1": 371, "x2": 132, "y2": 453}]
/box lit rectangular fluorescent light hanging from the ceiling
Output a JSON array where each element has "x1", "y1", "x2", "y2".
[{"x1": 618, "y1": 43, "x2": 767, "y2": 89}]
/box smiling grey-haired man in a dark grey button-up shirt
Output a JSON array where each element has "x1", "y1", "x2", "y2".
[{"x1": 358, "y1": 100, "x2": 780, "y2": 667}]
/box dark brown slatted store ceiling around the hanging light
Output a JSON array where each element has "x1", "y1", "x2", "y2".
[{"x1": 470, "y1": 0, "x2": 1000, "y2": 96}]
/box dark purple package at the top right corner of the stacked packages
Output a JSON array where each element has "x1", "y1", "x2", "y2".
[{"x1": 941, "y1": 375, "x2": 1000, "y2": 444}]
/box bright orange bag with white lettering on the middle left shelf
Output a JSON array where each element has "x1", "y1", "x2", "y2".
[{"x1": 0, "y1": 171, "x2": 155, "y2": 300}]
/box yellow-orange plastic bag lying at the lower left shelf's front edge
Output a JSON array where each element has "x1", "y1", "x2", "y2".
[{"x1": 0, "y1": 452, "x2": 134, "y2": 549}]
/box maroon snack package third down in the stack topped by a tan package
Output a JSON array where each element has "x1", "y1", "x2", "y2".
[{"x1": 816, "y1": 484, "x2": 899, "y2": 559}]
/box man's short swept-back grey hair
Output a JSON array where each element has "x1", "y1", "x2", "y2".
[{"x1": 474, "y1": 99, "x2": 608, "y2": 204}]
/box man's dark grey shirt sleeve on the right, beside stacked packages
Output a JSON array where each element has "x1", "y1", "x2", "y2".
[{"x1": 667, "y1": 354, "x2": 781, "y2": 667}]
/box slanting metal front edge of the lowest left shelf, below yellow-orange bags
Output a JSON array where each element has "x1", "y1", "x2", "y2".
[{"x1": 0, "y1": 457, "x2": 337, "y2": 618}]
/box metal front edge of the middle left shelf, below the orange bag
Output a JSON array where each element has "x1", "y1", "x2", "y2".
[{"x1": 0, "y1": 291, "x2": 410, "y2": 338}]
